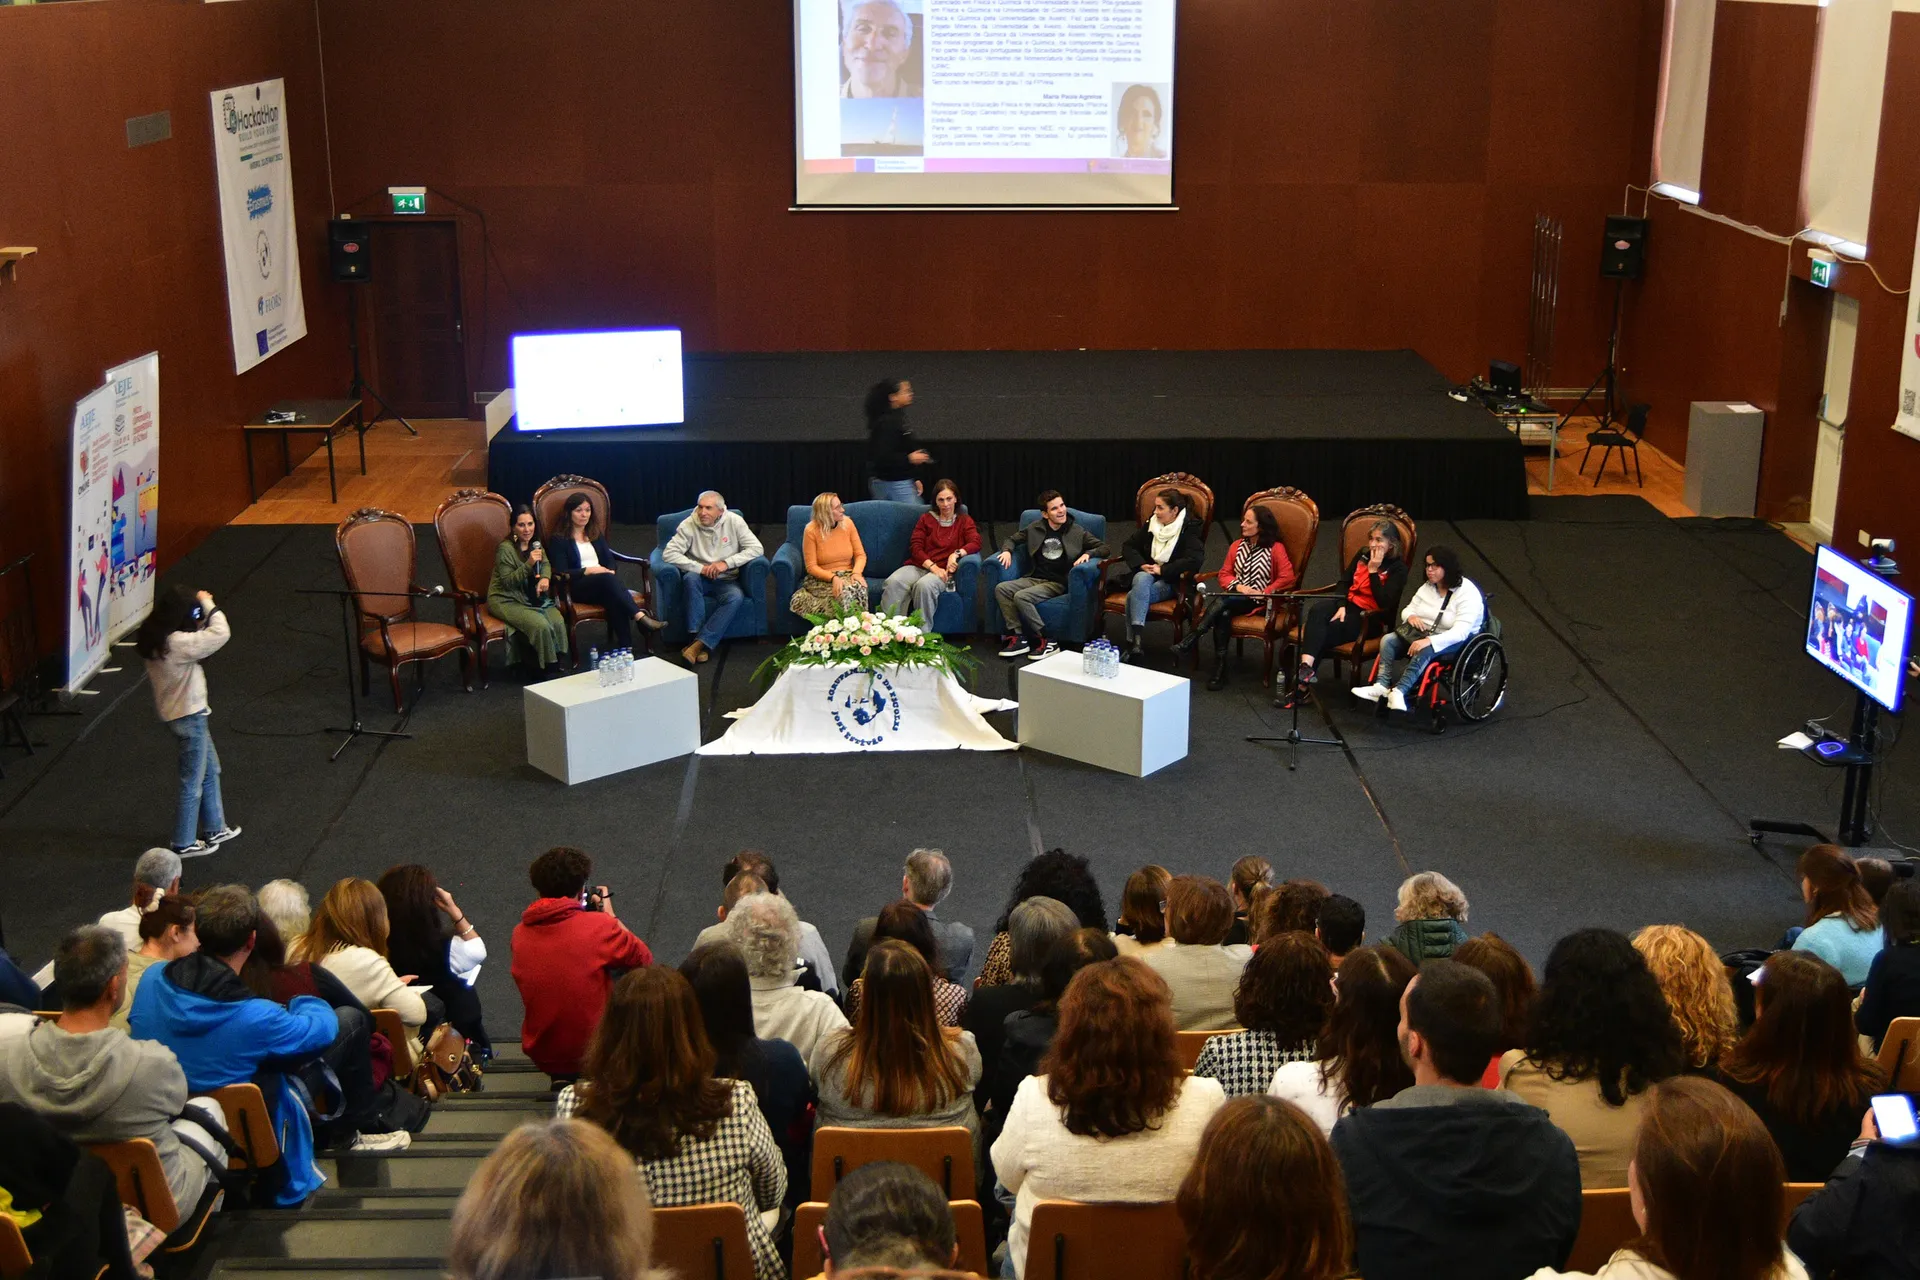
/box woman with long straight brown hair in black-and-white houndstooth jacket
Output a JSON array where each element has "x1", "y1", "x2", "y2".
[{"x1": 555, "y1": 967, "x2": 787, "y2": 1280}]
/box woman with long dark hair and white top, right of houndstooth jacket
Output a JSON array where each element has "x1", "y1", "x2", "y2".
[{"x1": 1267, "y1": 944, "x2": 1415, "y2": 1134}]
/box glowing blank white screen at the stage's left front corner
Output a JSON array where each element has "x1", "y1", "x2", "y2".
[{"x1": 513, "y1": 328, "x2": 687, "y2": 432}]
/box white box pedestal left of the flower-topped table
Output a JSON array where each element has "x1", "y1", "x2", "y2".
[{"x1": 524, "y1": 658, "x2": 701, "y2": 787}]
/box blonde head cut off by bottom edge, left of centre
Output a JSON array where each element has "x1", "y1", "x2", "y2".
[{"x1": 447, "y1": 1121, "x2": 660, "y2": 1280}]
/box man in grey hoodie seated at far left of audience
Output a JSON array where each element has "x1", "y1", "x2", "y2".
[{"x1": 0, "y1": 925, "x2": 221, "y2": 1219}]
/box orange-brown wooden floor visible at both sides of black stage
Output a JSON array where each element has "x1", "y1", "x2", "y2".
[{"x1": 234, "y1": 418, "x2": 1693, "y2": 524}]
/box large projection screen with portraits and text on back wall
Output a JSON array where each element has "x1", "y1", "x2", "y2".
[{"x1": 793, "y1": 0, "x2": 1175, "y2": 207}]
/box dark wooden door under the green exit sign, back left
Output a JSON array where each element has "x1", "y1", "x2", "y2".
[{"x1": 369, "y1": 219, "x2": 467, "y2": 418}]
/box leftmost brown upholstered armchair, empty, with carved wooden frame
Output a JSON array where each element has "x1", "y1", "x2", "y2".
[{"x1": 334, "y1": 507, "x2": 474, "y2": 712}]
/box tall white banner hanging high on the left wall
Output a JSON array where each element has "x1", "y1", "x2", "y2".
[{"x1": 213, "y1": 81, "x2": 307, "y2": 374}]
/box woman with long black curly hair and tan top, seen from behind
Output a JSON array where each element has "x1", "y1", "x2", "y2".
[{"x1": 1500, "y1": 929, "x2": 1686, "y2": 1192}]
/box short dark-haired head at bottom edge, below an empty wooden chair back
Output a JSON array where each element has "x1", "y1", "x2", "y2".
[{"x1": 820, "y1": 1161, "x2": 960, "y2": 1280}]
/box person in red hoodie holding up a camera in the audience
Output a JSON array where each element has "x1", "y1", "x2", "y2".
[{"x1": 513, "y1": 844, "x2": 653, "y2": 1086}]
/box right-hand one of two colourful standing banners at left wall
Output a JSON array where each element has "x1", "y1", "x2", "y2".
[{"x1": 108, "y1": 351, "x2": 159, "y2": 643}]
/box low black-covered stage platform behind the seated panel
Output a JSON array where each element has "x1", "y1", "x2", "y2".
[{"x1": 488, "y1": 351, "x2": 1526, "y2": 524}]
